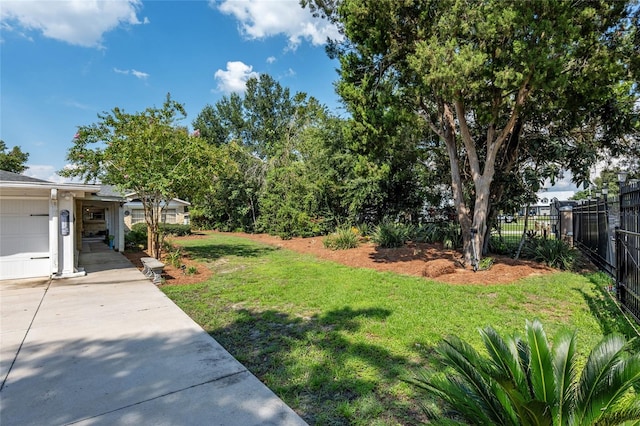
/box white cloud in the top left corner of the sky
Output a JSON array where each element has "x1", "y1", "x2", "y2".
[{"x1": 0, "y1": 0, "x2": 149, "y2": 47}]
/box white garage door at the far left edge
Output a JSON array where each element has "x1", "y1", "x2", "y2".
[{"x1": 0, "y1": 199, "x2": 51, "y2": 280}]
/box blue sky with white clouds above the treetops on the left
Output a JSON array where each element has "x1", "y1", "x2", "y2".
[{"x1": 0, "y1": 0, "x2": 341, "y2": 181}]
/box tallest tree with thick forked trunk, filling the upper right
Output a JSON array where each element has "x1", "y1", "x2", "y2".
[{"x1": 302, "y1": 0, "x2": 638, "y2": 262}]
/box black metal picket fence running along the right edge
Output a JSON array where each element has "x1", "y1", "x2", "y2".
[{"x1": 571, "y1": 181, "x2": 640, "y2": 323}]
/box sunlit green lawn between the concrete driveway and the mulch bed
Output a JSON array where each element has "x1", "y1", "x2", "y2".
[{"x1": 162, "y1": 234, "x2": 629, "y2": 425}]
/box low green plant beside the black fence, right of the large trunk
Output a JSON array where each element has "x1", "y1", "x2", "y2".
[{"x1": 521, "y1": 237, "x2": 580, "y2": 271}]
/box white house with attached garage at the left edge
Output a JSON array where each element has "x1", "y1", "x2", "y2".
[{"x1": 0, "y1": 171, "x2": 125, "y2": 280}]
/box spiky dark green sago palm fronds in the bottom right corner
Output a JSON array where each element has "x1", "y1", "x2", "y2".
[{"x1": 411, "y1": 320, "x2": 640, "y2": 426}]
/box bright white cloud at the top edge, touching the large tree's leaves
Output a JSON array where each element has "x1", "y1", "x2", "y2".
[{"x1": 216, "y1": 0, "x2": 341, "y2": 49}]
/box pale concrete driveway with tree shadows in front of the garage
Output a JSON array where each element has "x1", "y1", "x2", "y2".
[{"x1": 0, "y1": 243, "x2": 305, "y2": 426}]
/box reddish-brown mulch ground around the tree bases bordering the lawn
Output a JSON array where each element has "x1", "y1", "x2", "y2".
[{"x1": 125, "y1": 232, "x2": 554, "y2": 285}]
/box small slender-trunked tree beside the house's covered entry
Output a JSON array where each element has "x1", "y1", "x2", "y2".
[{"x1": 59, "y1": 95, "x2": 215, "y2": 258}]
